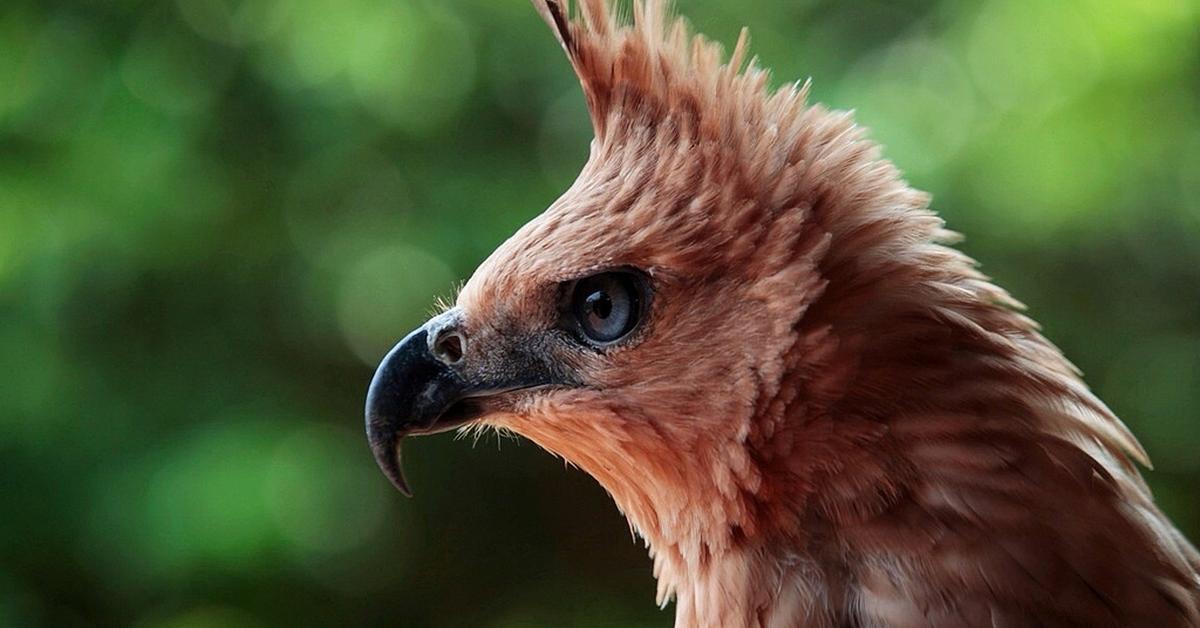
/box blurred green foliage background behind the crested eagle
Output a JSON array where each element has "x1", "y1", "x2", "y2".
[{"x1": 0, "y1": 0, "x2": 1200, "y2": 627}]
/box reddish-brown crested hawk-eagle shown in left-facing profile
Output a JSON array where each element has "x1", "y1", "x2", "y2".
[{"x1": 366, "y1": 0, "x2": 1200, "y2": 628}]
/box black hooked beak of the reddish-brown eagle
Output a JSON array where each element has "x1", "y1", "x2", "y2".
[{"x1": 366, "y1": 309, "x2": 570, "y2": 497}]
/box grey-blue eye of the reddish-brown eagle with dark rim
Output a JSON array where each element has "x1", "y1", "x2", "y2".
[{"x1": 570, "y1": 270, "x2": 646, "y2": 346}]
